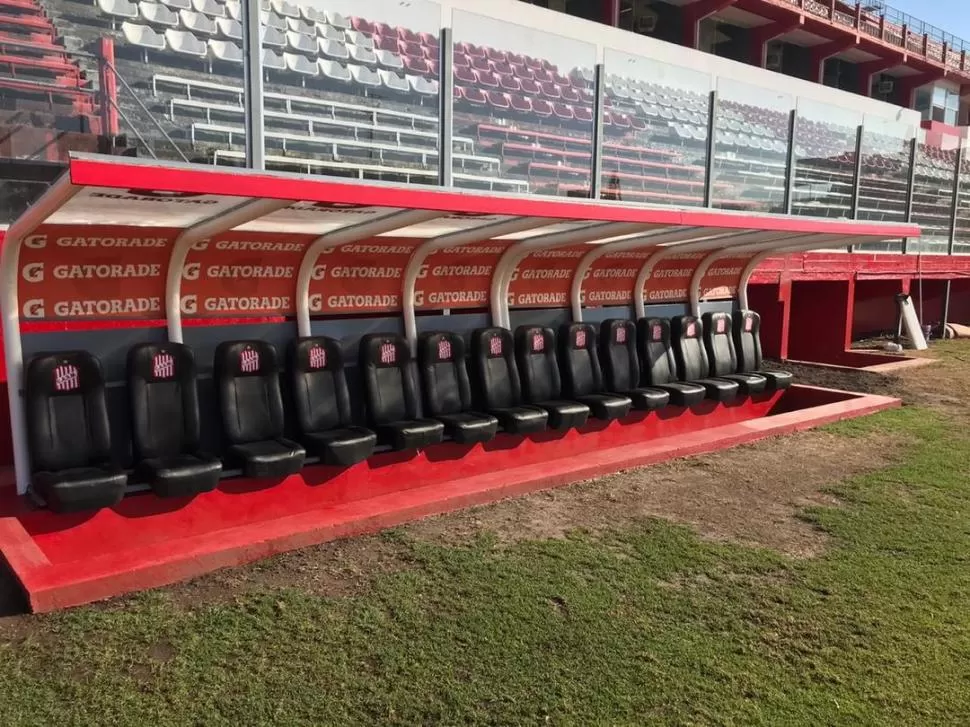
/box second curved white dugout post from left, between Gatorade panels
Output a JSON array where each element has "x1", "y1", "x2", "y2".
[{"x1": 165, "y1": 198, "x2": 292, "y2": 343}]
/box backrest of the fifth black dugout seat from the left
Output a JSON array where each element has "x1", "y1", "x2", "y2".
[{"x1": 360, "y1": 333, "x2": 418, "y2": 426}]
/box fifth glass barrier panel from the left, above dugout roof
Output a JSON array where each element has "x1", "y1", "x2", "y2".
[{"x1": 712, "y1": 78, "x2": 795, "y2": 213}]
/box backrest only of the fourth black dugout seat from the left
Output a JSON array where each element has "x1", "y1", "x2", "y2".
[{"x1": 288, "y1": 336, "x2": 351, "y2": 433}]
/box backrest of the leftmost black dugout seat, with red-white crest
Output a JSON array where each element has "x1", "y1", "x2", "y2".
[{"x1": 24, "y1": 351, "x2": 111, "y2": 472}]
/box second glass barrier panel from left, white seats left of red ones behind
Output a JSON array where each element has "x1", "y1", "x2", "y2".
[{"x1": 258, "y1": 0, "x2": 441, "y2": 184}]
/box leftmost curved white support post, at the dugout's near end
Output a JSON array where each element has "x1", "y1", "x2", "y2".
[{"x1": 0, "y1": 174, "x2": 81, "y2": 495}]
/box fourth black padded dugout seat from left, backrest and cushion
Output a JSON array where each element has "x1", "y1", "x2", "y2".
[{"x1": 288, "y1": 336, "x2": 377, "y2": 467}]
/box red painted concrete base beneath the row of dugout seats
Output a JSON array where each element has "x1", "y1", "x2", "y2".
[{"x1": 0, "y1": 386, "x2": 899, "y2": 612}]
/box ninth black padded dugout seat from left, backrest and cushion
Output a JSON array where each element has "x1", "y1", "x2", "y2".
[{"x1": 559, "y1": 323, "x2": 633, "y2": 421}]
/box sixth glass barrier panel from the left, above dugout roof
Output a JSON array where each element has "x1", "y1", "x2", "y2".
[{"x1": 792, "y1": 98, "x2": 863, "y2": 218}]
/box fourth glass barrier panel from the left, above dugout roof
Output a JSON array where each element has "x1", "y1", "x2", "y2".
[{"x1": 600, "y1": 48, "x2": 712, "y2": 206}]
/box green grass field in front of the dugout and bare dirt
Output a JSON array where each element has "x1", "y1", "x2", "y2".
[{"x1": 0, "y1": 347, "x2": 970, "y2": 727}]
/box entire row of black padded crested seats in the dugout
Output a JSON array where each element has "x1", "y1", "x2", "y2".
[{"x1": 25, "y1": 311, "x2": 791, "y2": 512}]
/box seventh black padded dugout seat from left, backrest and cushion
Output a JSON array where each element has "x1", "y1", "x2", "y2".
[{"x1": 469, "y1": 327, "x2": 549, "y2": 434}]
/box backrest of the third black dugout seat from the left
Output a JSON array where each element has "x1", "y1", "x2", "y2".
[{"x1": 214, "y1": 340, "x2": 283, "y2": 444}]
